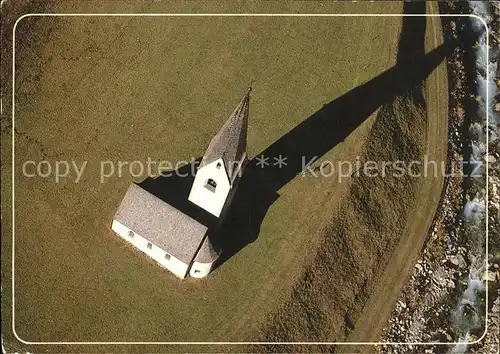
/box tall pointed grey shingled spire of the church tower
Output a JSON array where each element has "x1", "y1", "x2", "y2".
[{"x1": 199, "y1": 89, "x2": 251, "y2": 182}]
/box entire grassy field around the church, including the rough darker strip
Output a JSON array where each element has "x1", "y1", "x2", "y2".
[{"x1": 2, "y1": 2, "x2": 447, "y2": 351}]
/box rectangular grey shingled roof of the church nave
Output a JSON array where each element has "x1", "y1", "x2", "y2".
[{"x1": 114, "y1": 183, "x2": 208, "y2": 264}]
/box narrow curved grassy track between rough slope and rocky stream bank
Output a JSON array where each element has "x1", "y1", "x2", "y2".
[{"x1": 340, "y1": 3, "x2": 447, "y2": 352}]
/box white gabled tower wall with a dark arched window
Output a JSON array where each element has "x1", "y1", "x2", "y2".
[{"x1": 188, "y1": 159, "x2": 231, "y2": 217}]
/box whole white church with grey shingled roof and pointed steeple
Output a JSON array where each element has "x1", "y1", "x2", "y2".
[{"x1": 111, "y1": 89, "x2": 251, "y2": 279}]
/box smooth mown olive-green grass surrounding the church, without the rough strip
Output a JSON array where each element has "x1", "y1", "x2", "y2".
[{"x1": 2, "y1": 4, "x2": 400, "y2": 350}]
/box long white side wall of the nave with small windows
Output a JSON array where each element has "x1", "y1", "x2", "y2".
[{"x1": 111, "y1": 220, "x2": 188, "y2": 279}]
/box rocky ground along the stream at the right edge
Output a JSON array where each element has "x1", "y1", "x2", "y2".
[{"x1": 380, "y1": 1, "x2": 500, "y2": 353}]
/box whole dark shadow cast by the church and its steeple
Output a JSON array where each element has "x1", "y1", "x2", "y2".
[{"x1": 140, "y1": 1, "x2": 451, "y2": 268}]
